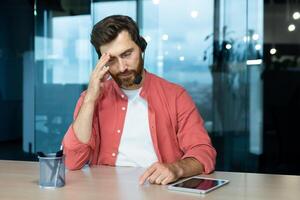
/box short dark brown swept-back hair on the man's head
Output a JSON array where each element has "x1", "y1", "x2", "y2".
[{"x1": 91, "y1": 15, "x2": 147, "y2": 58}]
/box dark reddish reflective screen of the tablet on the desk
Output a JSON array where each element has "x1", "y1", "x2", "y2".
[{"x1": 173, "y1": 178, "x2": 225, "y2": 190}]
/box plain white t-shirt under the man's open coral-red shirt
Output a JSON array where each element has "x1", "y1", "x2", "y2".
[{"x1": 116, "y1": 88, "x2": 158, "y2": 167}]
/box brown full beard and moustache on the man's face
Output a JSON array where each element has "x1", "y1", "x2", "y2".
[{"x1": 111, "y1": 57, "x2": 144, "y2": 88}]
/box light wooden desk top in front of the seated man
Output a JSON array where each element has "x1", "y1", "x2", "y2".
[{"x1": 0, "y1": 160, "x2": 300, "y2": 200}]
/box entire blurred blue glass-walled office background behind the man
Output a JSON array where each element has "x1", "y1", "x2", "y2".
[{"x1": 0, "y1": 0, "x2": 300, "y2": 174}]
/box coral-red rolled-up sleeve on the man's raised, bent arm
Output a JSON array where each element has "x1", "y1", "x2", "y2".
[{"x1": 62, "y1": 93, "x2": 98, "y2": 170}]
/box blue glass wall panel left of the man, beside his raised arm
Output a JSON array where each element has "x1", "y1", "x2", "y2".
[{"x1": 33, "y1": 1, "x2": 93, "y2": 152}]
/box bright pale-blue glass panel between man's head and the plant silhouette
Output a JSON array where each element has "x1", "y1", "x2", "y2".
[{"x1": 141, "y1": 0, "x2": 214, "y2": 130}]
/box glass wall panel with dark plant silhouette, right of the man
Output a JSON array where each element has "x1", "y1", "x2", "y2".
[{"x1": 212, "y1": 0, "x2": 263, "y2": 170}]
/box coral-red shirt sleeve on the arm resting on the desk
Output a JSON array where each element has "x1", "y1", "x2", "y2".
[{"x1": 177, "y1": 90, "x2": 217, "y2": 174}]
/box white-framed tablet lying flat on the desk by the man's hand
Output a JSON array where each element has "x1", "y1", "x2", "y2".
[{"x1": 168, "y1": 176, "x2": 229, "y2": 194}]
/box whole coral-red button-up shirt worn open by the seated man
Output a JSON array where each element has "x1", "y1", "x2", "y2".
[{"x1": 63, "y1": 72, "x2": 216, "y2": 173}]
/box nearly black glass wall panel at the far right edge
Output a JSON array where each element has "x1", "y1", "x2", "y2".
[{"x1": 262, "y1": 0, "x2": 300, "y2": 175}]
